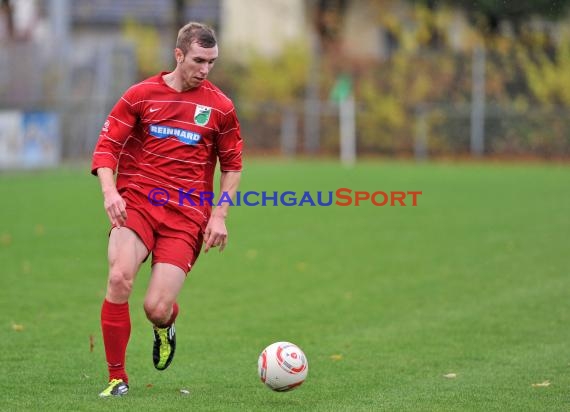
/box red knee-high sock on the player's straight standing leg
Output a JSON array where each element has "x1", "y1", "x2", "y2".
[{"x1": 101, "y1": 299, "x2": 131, "y2": 383}]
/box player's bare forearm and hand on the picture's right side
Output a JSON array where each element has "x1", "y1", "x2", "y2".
[{"x1": 204, "y1": 172, "x2": 241, "y2": 253}]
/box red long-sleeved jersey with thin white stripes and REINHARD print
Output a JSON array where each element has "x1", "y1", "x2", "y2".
[{"x1": 91, "y1": 72, "x2": 242, "y2": 224}]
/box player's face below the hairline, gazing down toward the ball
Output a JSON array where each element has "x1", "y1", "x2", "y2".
[{"x1": 176, "y1": 43, "x2": 218, "y2": 88}]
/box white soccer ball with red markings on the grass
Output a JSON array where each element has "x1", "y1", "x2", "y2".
[{"x1": 257, "y1": 342, "x2": 309, "y2": 392}]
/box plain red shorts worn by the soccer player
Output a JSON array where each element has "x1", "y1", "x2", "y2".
[{"x1": 117, "y1": 190, "x2": 203, "y2": 273}]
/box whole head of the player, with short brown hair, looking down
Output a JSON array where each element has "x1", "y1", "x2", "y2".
[{"x1": 174, "y1": 22, "x2": 218, "y2": 88}]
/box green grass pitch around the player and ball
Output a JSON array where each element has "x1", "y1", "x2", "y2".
[{"x1": 0, "y1": 160, "x2": 570, "y2": 411}]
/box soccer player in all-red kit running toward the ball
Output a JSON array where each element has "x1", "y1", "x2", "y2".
[{"x1": 91, "y1": 22, "x2": 242, "y2": 397}]
